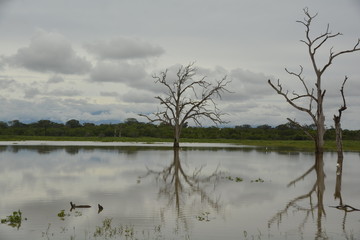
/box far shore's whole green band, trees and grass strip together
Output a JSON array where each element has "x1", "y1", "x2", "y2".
[{"x1": 0, "y1": 119, "x2": 360, "y2": 151}]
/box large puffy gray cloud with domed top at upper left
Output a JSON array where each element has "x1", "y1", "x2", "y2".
[{"x1": 5, "y1": 31, "x2": 91, "y2": 74}]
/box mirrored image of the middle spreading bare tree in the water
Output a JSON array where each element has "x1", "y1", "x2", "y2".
[{"x1": 139, "y1": 149, "x2": 222, "y2": 232}]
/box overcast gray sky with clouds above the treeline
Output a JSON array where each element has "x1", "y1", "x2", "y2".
[{"x1": 0, "y1": 0, "x2": 360, "y2": 129}]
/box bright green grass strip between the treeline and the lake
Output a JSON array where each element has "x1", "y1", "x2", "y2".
[{"x1": 0, "y1": 135, "x2": 360, "y2": 152}]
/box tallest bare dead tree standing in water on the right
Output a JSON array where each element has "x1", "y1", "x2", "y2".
[{"x1": 268, "y1": 8, "x2": 360, "y2": 153}]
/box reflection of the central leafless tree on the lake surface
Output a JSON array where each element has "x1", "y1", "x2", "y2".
[{"x1": 141, "y1": 148, "x2": 221, "y2": 229}]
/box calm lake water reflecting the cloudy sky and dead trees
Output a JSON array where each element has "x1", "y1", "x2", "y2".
[{"x1": 0, "y1": 143, "x2": 360, "y2": 240}]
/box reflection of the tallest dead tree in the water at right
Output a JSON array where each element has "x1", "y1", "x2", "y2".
[{"x1": 268, "y1": 154, "x2": 326, "y2": 236}]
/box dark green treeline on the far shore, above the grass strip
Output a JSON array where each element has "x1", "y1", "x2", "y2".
[{"x1": 0, "y1": 118, "x2": 360, "y2": 140}]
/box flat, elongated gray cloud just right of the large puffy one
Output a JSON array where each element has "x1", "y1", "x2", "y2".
[{"x1": 84, "y1": 37, "x2": 165, "y2": 60}]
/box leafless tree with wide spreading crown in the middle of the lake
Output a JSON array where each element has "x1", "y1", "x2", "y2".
[{"x1": 140, "y1": 63, "x2": 230, "y2": 147}]
